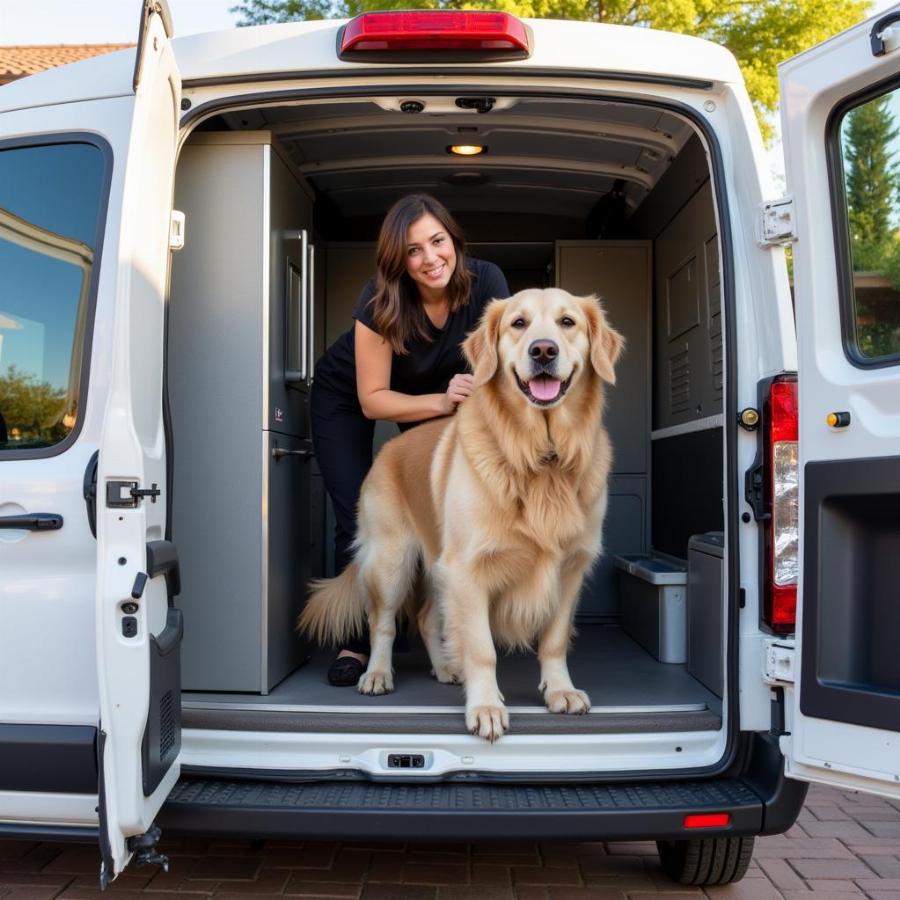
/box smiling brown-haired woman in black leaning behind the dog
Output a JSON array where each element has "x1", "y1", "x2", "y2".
[{"x1": 312, "y1": 194, "x2": 509, "y2": 685}]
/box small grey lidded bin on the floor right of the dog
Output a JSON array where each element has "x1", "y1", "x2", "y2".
[{"x1": 615, "y1": 556, "x2": 687, "y2": 663}]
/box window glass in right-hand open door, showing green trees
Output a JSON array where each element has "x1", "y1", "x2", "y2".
[{"x1": 841, "y1": 91, "x2": 900, "y2": 359}]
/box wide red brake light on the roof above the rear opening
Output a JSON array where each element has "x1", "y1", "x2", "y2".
[{"x1": 340, "y1": 10, "x2": 529, "y2": 56}]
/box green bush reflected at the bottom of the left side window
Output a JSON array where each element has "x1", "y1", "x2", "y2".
[{"x1": 0, "y1": 366, "x2": 70, "y2": 448}]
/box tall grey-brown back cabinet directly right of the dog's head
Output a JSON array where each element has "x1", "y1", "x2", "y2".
[{"x1": 556, "y1": 241, "x2": 652, "y2": 621}]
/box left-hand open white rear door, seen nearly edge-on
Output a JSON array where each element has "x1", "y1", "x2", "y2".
[{"x1": 96, "y1": 0, "x2": 181, "y2": 882}]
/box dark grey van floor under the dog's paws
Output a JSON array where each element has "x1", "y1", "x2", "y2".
[{"x1": 182, "y1": 625, "x2": 722, "y2": 734}]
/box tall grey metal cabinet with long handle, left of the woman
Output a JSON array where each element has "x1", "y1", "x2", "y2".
[{"x1": 167, "y1": 132, "x2": 314, "y2": 693}]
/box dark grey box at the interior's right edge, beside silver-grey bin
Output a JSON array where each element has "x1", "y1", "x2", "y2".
[{"x1": 687, "y1": 531, "x2": 725, "y2": 697}]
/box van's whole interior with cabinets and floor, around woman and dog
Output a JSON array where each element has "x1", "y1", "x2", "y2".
[{"x1": 166, "y1": 49, "x2": 737, "y2": 776}]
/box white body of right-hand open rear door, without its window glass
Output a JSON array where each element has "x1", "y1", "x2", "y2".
[{"x1": 780, "y1": 8, "x2": 900, "y2": 797}]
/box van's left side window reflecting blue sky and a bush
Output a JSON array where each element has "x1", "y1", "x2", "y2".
[{"x1": 0, "y1": 143, "x2": 106, "y2": 458}]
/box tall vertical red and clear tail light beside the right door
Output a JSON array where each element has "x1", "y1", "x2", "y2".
[{"x1": 761, "y1": 375, "x2": 800, "y2": 634}]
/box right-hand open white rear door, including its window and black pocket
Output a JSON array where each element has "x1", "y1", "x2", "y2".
[{"x1": 781, "y1": 7, "x2": 900, "y2": 797}]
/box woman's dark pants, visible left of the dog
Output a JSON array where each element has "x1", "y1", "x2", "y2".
[{"x1": 310, "y1": 385, "x2": 375, "y2": 654}]
